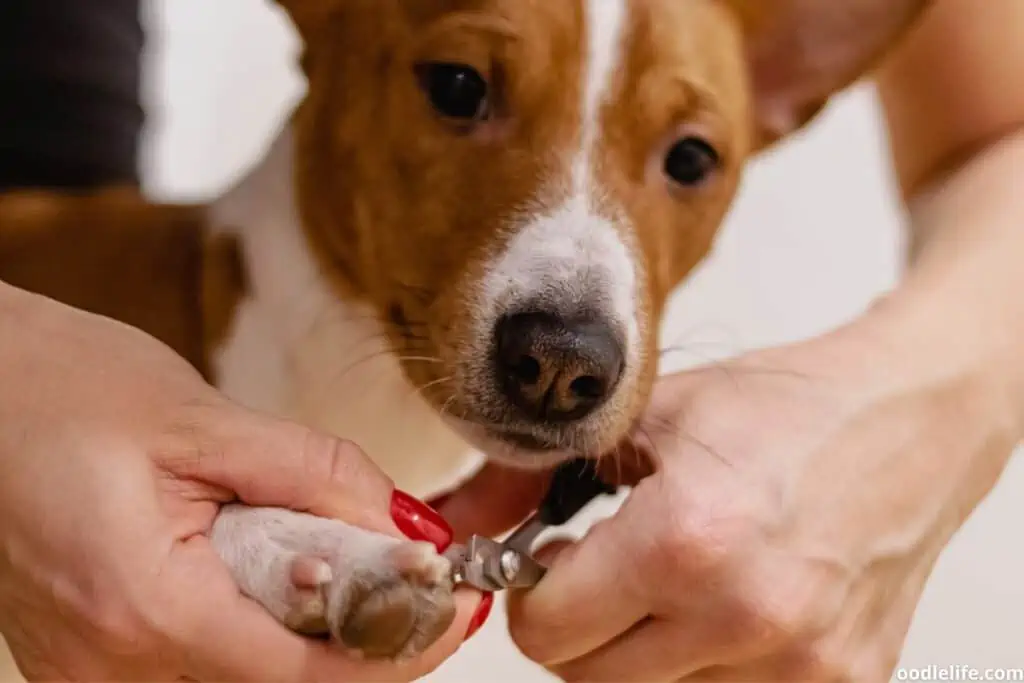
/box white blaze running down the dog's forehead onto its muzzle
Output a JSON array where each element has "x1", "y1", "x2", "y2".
[{"x1": 477, "y1": 0, "x2": 641, "y2": 378}]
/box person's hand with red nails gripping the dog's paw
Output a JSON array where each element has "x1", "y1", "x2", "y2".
[{"x1": 0, "y1": 285, "x2": 480, "y2": 681}]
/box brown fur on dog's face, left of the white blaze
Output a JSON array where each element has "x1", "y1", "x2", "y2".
[{"x1": 296, "y1": 0, "x2": 598, "y2": 421}]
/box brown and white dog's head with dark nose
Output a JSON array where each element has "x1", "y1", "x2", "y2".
[{"x1": 282, "y1": 0, "x2": 926, "y2": 465}]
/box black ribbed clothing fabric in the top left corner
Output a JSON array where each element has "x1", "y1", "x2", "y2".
[{"x1": 0, "y1": 0, "x2": 144, "y2": 190}]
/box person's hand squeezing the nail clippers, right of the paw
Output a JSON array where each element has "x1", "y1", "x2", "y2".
[{"x1": 452, "y1": 307, "x2": 1018, "y2": 682}]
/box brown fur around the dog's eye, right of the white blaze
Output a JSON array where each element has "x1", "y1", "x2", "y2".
[{"x1": 598, "y1": 0, "x2": 751, "y2": 420}]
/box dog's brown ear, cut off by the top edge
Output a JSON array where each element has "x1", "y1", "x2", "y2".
[{"x1": 727, "y1": 0, "x2": 932, "y2": 147}]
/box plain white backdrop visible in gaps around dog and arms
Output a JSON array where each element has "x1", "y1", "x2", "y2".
[{"x1": 145, "y1": 0, "x2": 1024, "y2": 683}]
